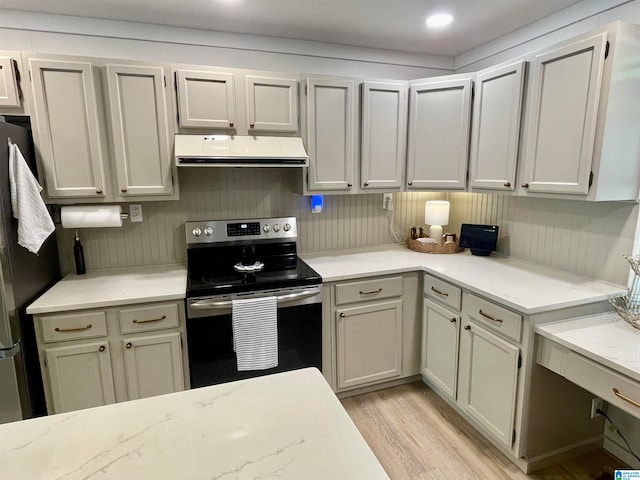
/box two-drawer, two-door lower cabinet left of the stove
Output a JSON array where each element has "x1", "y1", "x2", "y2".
[{"x1": 35, "y1": 302, "x2": 189, "y2": 414}]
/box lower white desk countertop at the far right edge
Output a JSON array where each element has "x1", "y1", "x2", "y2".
[{"x1": 535, "y1": 312, "x2": 640, "y2": 382}]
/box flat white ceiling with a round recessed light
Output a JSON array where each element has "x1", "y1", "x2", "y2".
[{"x1": 1, "y1": 0, "x2": 592, "y2": 57}]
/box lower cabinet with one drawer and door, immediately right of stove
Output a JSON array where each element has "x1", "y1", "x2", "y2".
[{"x1": 323, "y1": 272, "x2": 422, "y2": 395}]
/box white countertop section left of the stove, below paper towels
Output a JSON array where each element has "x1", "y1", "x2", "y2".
[{"x1": 27, "y1": 264, "x2": 187, "y2": 315}]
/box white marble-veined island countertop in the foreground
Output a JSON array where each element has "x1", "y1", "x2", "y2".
[{"x1": 0, "y1": 368, "x2": 389, "y2": 480}]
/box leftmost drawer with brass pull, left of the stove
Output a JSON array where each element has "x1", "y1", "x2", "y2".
[{"x1": 38, "y1": 311, "x2": 107, "y2": 343}]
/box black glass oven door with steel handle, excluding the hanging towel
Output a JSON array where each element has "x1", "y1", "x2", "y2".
[{"x1": 187, "y1": 285, "x2": 322, "y2": 388}]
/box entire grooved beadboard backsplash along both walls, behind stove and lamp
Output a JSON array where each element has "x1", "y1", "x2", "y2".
[{"x1": 58, "y1": 168, "x2": 638, "y2": 284}]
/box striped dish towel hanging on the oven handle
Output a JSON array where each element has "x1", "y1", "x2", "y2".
[{"x1": 231, "y1": 297, "x2": 278, "y2": 371}]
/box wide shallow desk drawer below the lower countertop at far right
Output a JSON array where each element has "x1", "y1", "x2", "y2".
[{"x1": 563, "y1": 351, "x2": 640, "y2": 418}]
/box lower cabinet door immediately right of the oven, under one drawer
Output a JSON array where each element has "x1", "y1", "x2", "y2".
[{"x1": 336, "y1": 300, "x2": 402, "y2": 388}]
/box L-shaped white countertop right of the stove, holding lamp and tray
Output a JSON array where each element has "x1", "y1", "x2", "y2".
[{"x1": 302, "y1": 246, "x2": 627, "y2": 314}]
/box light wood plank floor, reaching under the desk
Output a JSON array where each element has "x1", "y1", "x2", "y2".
[{"x1": 342, "y1": 382, "x2": 628, "y2": 480}]
